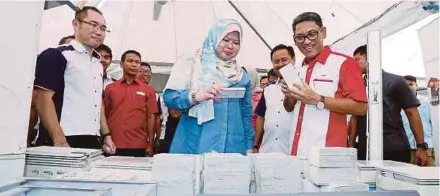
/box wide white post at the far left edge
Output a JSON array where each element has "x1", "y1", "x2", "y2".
[{"x1": 0, "y1": 1, "x2": 44, "y2": 155}]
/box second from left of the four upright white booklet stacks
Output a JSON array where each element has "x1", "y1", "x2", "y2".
[{"x1": 202, "y1": 153, "x2": 251, "y2": 194}]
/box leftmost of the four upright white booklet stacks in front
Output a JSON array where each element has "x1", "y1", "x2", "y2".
[{"x1": 153, "y1": 154, "x2": 201, "y2": 196}]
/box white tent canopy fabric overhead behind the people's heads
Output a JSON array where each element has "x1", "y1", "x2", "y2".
[{"x1": 40, "y1": 1, "x2": 395, "y2": 68}]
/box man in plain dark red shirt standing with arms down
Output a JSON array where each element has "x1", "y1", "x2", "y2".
[{"x1": 104, "y1": 50, "x2": 157, "y2": 157}]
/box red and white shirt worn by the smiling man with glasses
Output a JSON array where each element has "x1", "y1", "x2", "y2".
[{"x1": 291, "y1": 46, "x2": 367, "y2": 156}]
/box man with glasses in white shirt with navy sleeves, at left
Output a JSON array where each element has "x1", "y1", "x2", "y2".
[{"x1": 34, "y1": 6, "x2": 115, "y2": 153}]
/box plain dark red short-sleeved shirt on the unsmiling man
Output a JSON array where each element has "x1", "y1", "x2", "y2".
[{"x1": 104, "y1": 79, "x2": 157, "y2": 148}]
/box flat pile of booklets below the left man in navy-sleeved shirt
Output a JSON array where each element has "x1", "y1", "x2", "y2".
[{"x1": 25, "y1": 146, "x2": 104, "y2": 178}]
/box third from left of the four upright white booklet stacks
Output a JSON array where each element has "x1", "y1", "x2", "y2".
[{"x1": 253, "y1": 154, "x2": 302, "y2": 194}]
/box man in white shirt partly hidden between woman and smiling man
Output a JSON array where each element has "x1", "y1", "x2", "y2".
[{"x1": 254, "y1": 44, "x2": 295, "y2": 154}]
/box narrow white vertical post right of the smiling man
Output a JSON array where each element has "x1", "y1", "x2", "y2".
[{"x1": 367, "y1": 31, "x2": 383, "y2": 160}]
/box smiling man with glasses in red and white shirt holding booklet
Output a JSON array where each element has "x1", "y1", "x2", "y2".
[{"x1": 282, "y1": 12, "x2": 367, "y2": 156}]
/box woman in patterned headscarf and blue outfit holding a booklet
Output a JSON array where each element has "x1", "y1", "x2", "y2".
[{"x1": 163, "y1": 20, "x2": 254, "y2": 154}]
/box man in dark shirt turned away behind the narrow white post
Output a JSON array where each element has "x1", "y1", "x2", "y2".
[{"x1": 349, "y1": 45, "x2": 427, "y2": 165}]
